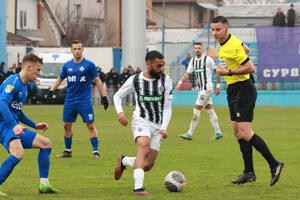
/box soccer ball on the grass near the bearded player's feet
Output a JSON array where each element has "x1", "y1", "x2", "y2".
[{"x1": 165, "y1": 171, "x2": 186, "y2": 192}]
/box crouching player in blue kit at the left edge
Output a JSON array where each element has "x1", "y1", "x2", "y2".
[{"x1": 0, "y1": 53, "x2": 58, "y2": 196}]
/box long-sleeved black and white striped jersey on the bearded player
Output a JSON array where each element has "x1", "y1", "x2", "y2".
[{"x1": 114, "y1": 73, "x2": 173, "y2": 127}]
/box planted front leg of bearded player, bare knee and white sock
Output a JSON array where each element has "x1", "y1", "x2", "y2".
[{"x1": 133, "y1": 136, "x2": 150, "y2": 195}]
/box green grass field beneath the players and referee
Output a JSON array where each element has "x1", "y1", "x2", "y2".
[{"x1": 0, "y1": 105, "x2": 300, "y2": 200}]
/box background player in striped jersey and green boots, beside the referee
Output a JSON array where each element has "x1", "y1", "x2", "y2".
[{"x1": 175, "y1": 42, "x2": 223, "y2": 141}]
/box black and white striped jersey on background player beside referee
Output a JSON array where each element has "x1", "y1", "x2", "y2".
[{"x1": 186, "y1": 55, "x2": 216, "y2": 91}]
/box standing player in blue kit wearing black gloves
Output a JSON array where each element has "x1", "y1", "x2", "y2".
[{"x1": 48, "y1": 40, "x2": 108, "y2": 158}]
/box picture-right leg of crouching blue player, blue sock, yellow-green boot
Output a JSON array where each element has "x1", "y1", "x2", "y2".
[{"x1": 29, "y1": 130, "x2": 58, "y2": 194}]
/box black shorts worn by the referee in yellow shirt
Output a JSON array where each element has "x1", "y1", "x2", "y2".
[{"x1": 227, "y1": 79, "x2": 257, "y2": 122}]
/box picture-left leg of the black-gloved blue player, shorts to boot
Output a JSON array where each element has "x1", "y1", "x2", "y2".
[{"x1": 56, "y1": 103, "x2": 78, "y2": 158}]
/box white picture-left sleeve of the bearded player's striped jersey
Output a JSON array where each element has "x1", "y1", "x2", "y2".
[{"x1": 114, "y1": 76, "x2": 134, "y2": 113}]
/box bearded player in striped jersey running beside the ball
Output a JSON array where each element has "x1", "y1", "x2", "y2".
[{"x1": 114, "y1": 51, "x2": 173, "y2": 195}]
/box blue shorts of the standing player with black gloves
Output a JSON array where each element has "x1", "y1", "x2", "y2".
[{"x1": 63, "y1": 102, "x2": 95, "y2": 123}]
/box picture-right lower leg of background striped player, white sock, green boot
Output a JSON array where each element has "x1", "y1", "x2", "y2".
[{"x1": 205, "y1": 104, "x2": 223, "y2": 141}]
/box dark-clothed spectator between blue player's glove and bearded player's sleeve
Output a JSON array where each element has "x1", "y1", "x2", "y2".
[{"x1": 106, "y1": 68, "x2": 120, "y2": 104}]
